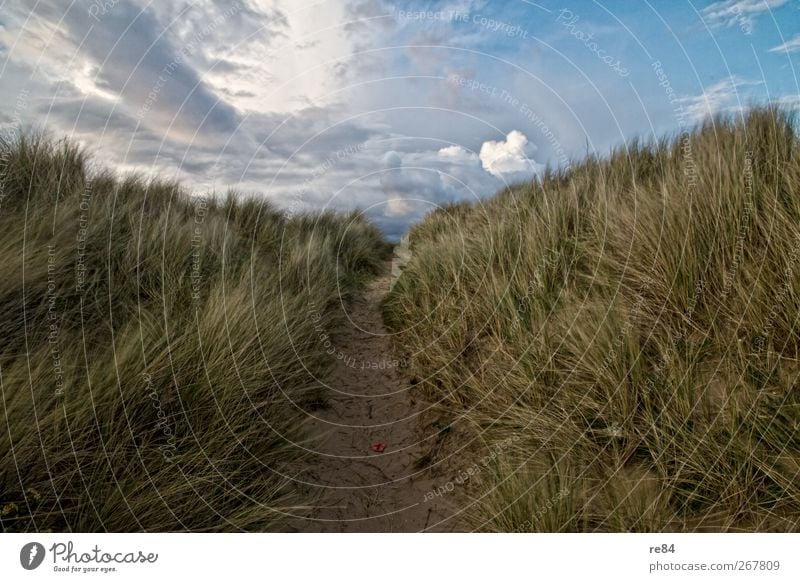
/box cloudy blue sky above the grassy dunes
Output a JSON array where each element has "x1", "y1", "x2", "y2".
[{"x1": 0, "y1": 0, "x2": 800, "y2": 238}]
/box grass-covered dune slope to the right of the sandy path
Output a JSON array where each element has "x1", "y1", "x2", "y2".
[{"x1": 386, "y1": 110, "x2": 800, "y2": 531}]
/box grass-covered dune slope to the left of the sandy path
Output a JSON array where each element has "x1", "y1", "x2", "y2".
[{"x1": 0, "y1": 138, "x2": 383, "y2": 531}]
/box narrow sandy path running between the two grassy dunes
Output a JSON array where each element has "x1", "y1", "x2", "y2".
[{"x1": 293, "y1": 264, "x2": 455, "y2": 532}]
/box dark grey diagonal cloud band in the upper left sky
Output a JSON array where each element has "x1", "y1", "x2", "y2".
[{"x1": 27, "y1": 0, "x2": 284, "y2": 142}]
